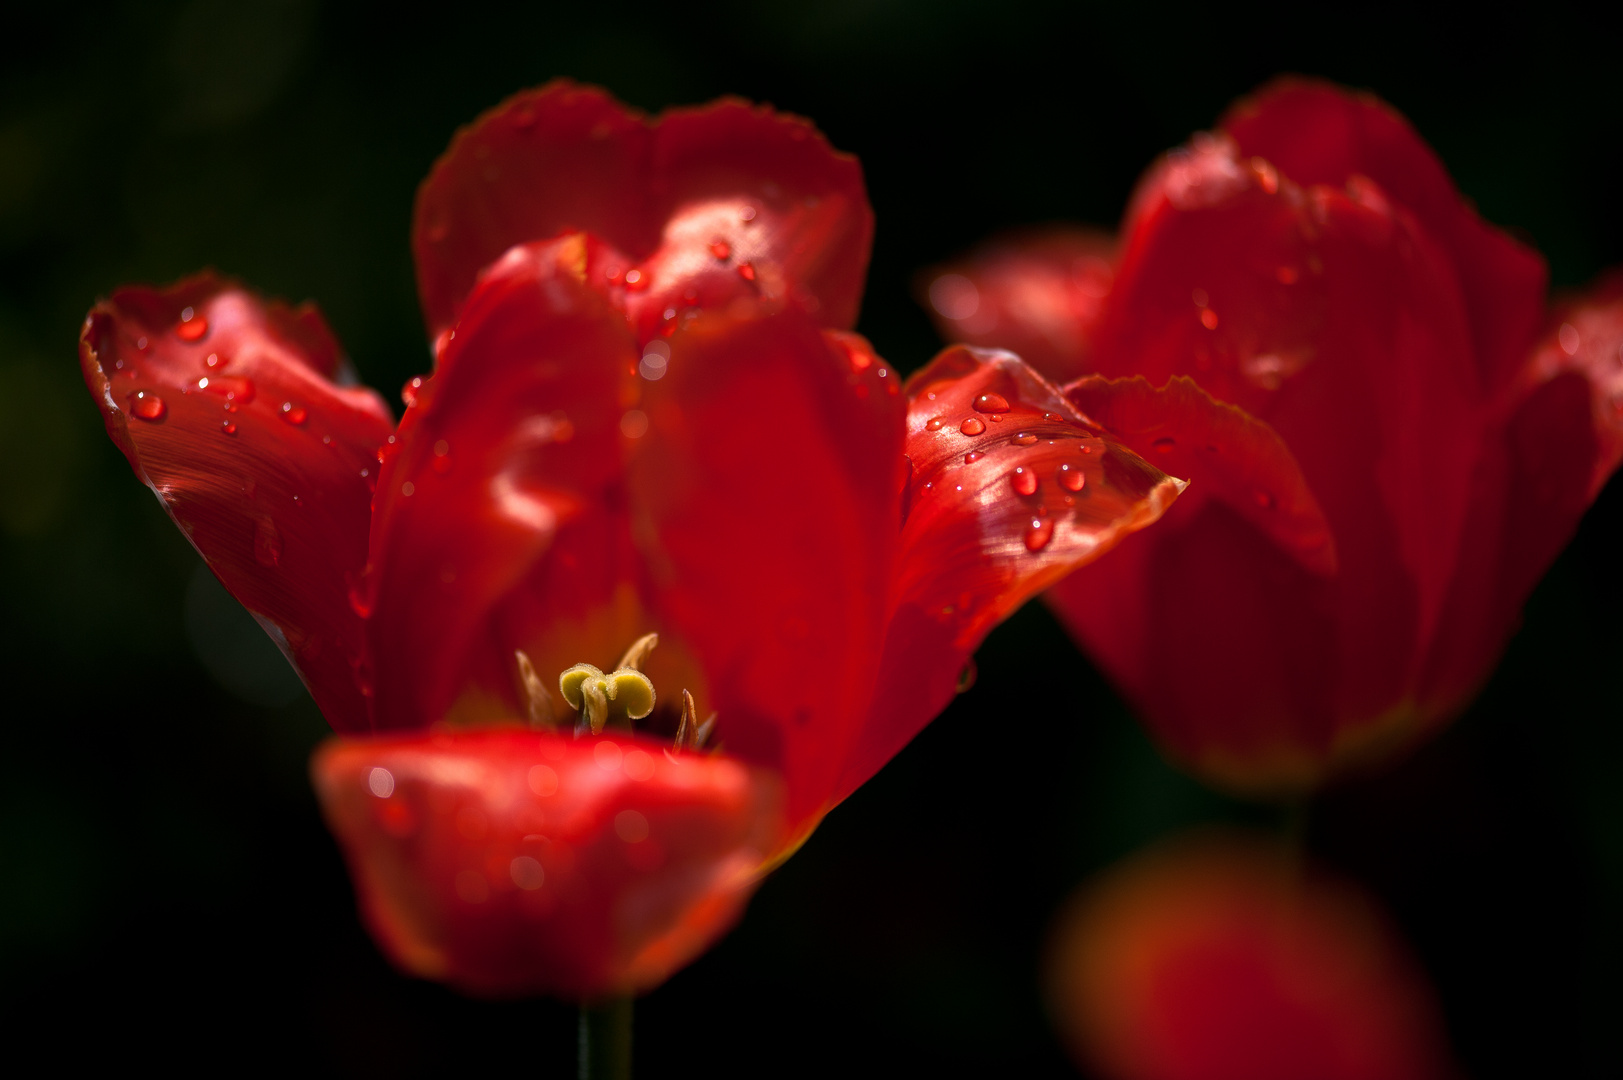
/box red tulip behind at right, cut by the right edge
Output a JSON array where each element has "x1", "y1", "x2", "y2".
[{"x1": 930, "y1": 80, "x2": 1623, "y2": 793}]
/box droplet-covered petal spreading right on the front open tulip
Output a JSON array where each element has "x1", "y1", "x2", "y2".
[{"x1": 839, "y1": 346, "x2": 1183, "y2": 799}]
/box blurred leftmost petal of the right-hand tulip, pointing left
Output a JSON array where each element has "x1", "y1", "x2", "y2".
[{"x1": 923, "y1": 226, "x2": 1117, "y2": 383}]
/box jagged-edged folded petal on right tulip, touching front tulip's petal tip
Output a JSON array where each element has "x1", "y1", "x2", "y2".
[{"x1": 1065, "y1": 375, "x2": 1336, "y2": 575}]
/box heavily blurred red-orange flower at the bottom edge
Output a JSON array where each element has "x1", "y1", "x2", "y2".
[{"x1": 1047, "y1": 835, "x2": 1453, "y2": 1080}]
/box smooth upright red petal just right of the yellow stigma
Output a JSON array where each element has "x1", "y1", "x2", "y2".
[{"x1": 628, "y1": 305, "x2": 906, "y2": 832}]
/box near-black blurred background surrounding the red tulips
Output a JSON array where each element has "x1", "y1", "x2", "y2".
[{"x1": 0, "y1": 0, "x2": 1623, "y2": 1077}]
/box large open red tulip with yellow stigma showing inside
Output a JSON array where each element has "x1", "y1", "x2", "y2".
[{"x1": 81, "y1": 84, "x2": 1180, "y2": 997}]
